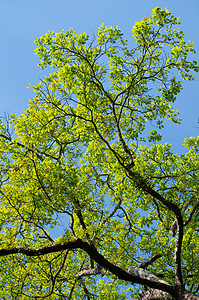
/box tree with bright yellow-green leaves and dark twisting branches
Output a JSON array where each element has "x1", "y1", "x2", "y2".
[{"x1": 0, "y1": 8, "x2": 199, "y2": 299}]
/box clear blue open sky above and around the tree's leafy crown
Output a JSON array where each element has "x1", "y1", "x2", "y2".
[{"x1": 0, "y1": 0, "x2": 199, "y2": 151}]
